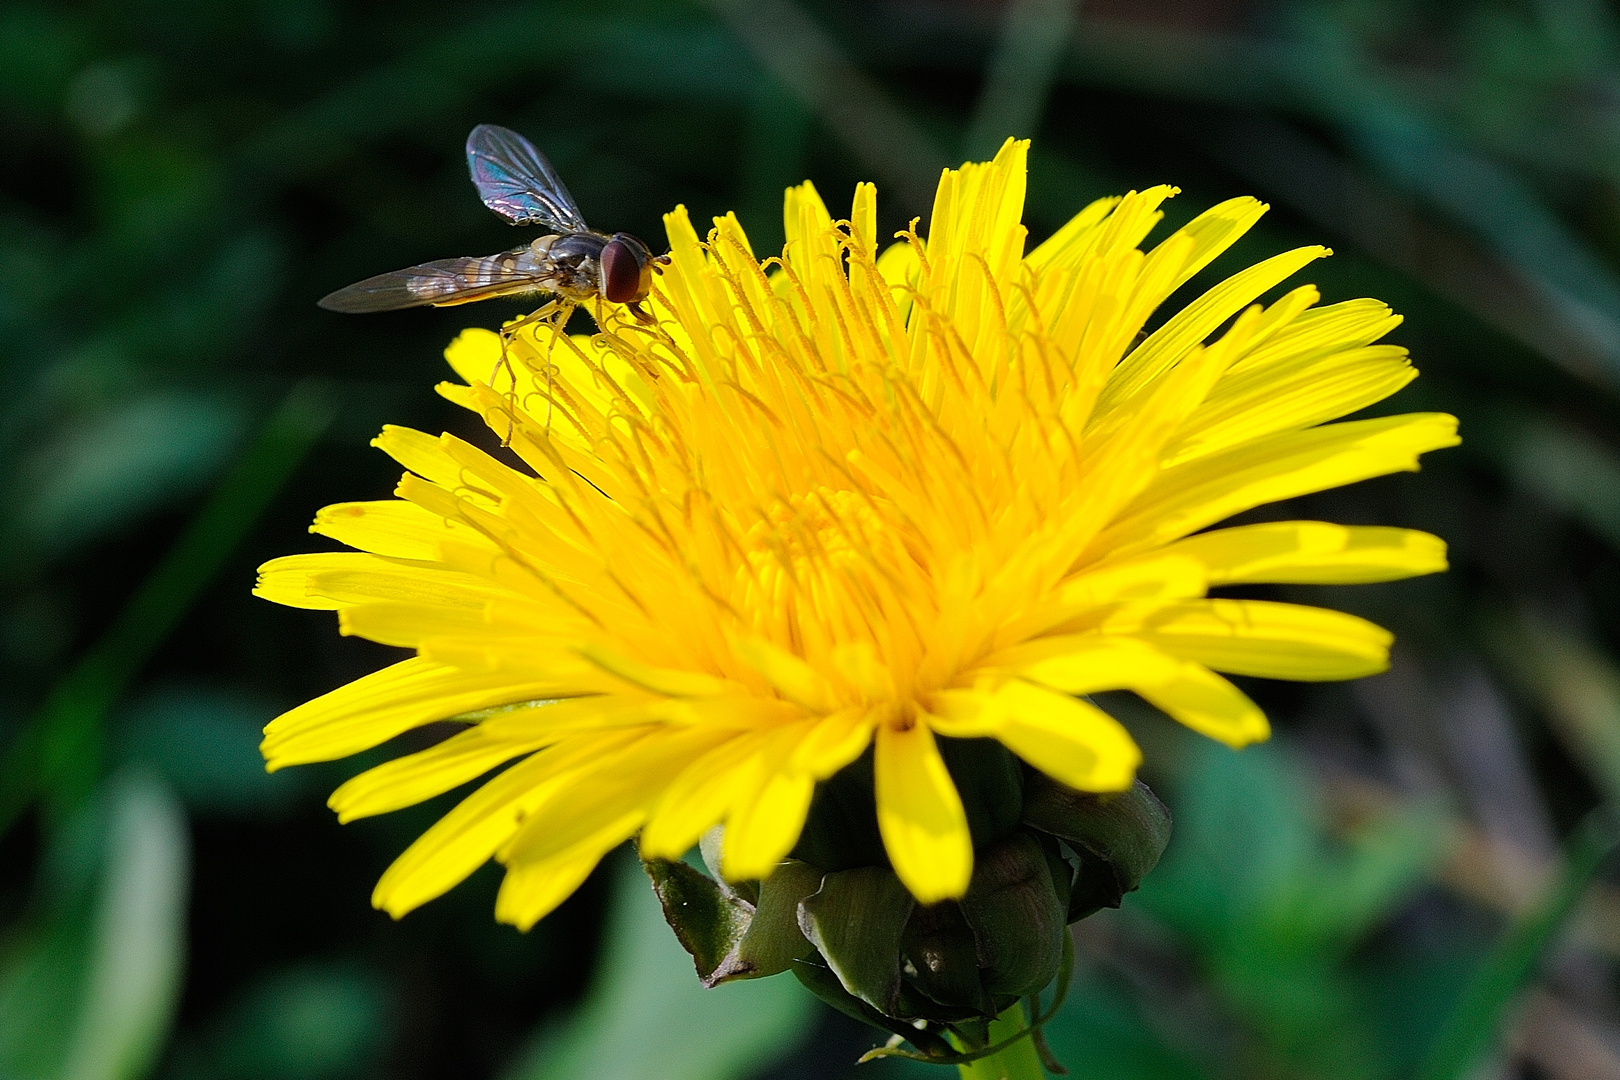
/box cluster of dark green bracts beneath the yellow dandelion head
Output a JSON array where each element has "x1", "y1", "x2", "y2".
[{"x1": 646, "y1": 738, "x2": 1170, "y2": 1056}]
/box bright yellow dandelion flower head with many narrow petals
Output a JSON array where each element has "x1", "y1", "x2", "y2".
[{"x1": 258, "y1": 141, "x2": 1456, "y2": 926}]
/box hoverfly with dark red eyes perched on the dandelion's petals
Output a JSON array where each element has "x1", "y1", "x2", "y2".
[{"x1": 319, "y1": 123, "x2": 667, "y2": 325}]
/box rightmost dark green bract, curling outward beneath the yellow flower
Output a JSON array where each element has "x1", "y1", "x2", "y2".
[{"x1": 1024, "y1": 771, "x2": 1170, "y2": 923}]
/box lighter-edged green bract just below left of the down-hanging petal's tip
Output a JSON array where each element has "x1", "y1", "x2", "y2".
[{"x1": 799, "y1": 866, "x2": 915, "y2": 1016}]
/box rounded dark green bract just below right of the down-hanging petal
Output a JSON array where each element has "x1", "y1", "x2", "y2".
[{"x1": 961, "y1": 831, "x2": 1068, "y2": 1015}]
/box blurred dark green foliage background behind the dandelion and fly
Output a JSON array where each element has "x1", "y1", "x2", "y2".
[{"x1": 0, "y1": 0, "x2": 1620, "y2": 1080}]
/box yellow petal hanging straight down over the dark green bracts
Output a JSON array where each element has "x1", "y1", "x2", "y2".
[{"x1": 873, "y1": 722, "x2": 974, "y2": 904}]
